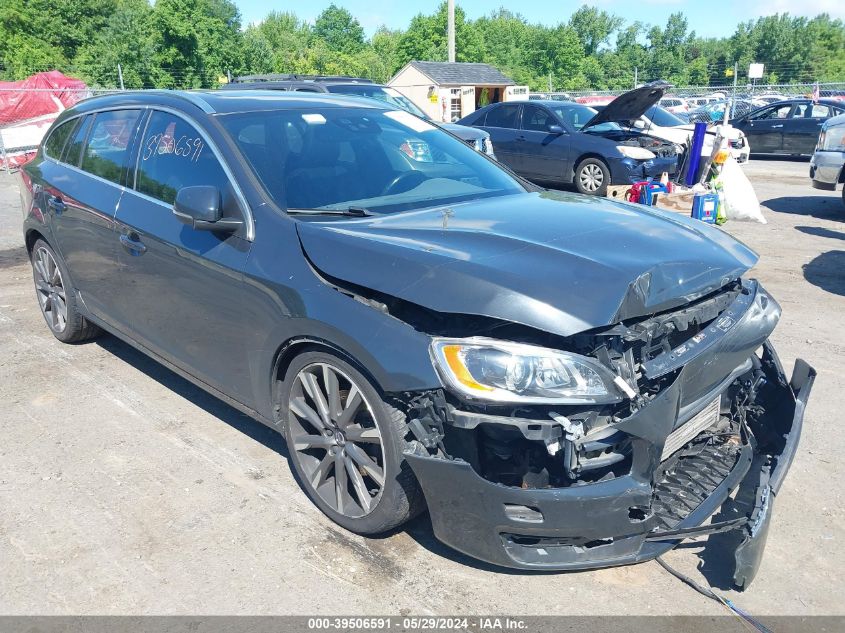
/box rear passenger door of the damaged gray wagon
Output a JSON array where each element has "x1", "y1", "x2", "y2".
[{"x1": 43, "y1": 110, "x2": 141, "y2": 324}]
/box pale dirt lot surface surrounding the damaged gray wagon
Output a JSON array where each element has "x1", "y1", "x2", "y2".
[{"x1": 0, "y1": 160, "x2": 845, "y2": 615}]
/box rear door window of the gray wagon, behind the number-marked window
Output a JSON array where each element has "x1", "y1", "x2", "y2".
[{"x1": 81, "y1": 110, "x2": 141, "y2": 184}]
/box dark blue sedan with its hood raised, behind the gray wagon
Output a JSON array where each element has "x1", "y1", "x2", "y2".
[{"x1": 459, "y1": 86, "x2": 678, "y2": 195}]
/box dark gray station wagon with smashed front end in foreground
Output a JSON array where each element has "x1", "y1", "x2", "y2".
[{"x1": 21, "y1": 90, "x2": 815, "y2": 586}]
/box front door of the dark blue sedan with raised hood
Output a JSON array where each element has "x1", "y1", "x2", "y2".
[{"x1": 516, "y1": 103, "x2": 572, "y2": 181}]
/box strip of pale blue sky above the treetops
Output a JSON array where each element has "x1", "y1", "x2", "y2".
[{"x1": 234, "y1": 0, "x2": 845, "y2": 37}]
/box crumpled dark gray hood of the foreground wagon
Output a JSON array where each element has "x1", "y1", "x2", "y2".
[{"x1": 297, "y1": 192, "x2": 757, "y2": 336}]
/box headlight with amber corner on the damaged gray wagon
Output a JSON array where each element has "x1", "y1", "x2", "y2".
[{"x1": 431, "y1": 338, "x2": 622, "y2": 404}]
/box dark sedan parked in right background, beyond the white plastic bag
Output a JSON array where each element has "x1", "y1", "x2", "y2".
[{"x1": 731, "y1": 99, "x2": 845, "y2": 156}]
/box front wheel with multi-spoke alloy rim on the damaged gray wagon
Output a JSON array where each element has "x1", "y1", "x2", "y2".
[{"x1": 279, "y1": 351, "x2": 423, "y2": 534}]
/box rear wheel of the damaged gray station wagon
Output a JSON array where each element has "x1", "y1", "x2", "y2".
[{"x1": 30, "y1": 239, "x2": 100, "y2": 343}]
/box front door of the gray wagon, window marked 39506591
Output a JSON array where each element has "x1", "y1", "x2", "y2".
[{"x1": 115, "y1": 110, "x2": 252, "y2": 404}]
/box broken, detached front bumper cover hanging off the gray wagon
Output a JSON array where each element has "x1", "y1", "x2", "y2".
[{"x1": 406, "y1": 341, "x2": 815, "y2": 588}]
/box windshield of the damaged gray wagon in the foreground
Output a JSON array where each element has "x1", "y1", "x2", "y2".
[{"x1": 219, "y1": 107, "x2": 525, "y2": 213}]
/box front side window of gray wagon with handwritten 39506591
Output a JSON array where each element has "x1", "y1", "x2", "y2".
[{"x1": 135, "y1": 112, "x2": 231, "y2": 204}]
